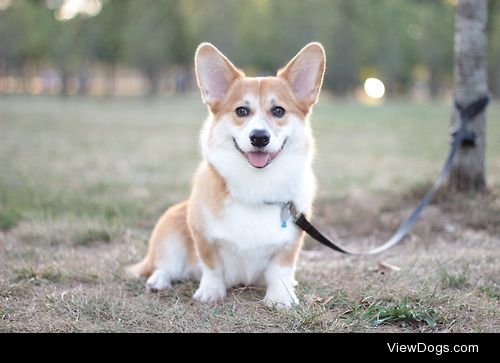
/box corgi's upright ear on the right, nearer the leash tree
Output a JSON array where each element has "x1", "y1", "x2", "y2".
[{"x1": 278, "y1": 43, "x2": 326, "y2": 108}]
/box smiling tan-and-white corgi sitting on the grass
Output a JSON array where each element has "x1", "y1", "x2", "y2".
[{"x1": 128, "y1": 43, "x2": 326, "y2": 308}]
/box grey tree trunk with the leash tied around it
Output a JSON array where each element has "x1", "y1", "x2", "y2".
[{"x1": 449, "y1": 0, "x2": 488, "y2": 191}]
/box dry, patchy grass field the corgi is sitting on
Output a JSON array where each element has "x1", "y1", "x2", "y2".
[{"x1": 0, "y1": 95, "x2": 500, "y2": 332}]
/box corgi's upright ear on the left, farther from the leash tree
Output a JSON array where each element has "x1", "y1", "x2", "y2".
[{"x1": 194, "y1": 43, "x2": 244, "y2": 107}]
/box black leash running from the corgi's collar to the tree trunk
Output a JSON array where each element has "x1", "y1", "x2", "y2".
[{"x1": 286, "y1": 96, "x2": 489, "y2": 255}]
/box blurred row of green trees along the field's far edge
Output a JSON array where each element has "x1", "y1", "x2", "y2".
[{"x1": 0, "y1": 0, "x2": 500, "y2": 99}]
